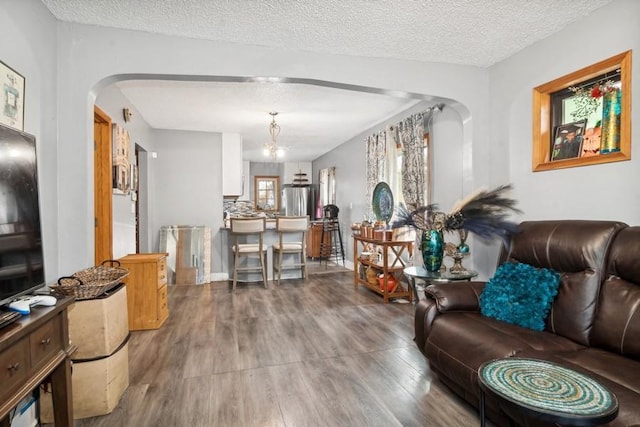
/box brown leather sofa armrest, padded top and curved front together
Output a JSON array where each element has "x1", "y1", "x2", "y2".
[{"x1": 414, "y1": 282, "x2": 485, "y2": 353}]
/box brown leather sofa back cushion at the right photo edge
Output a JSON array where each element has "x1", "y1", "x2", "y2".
[{"x1": 591, "y1": 227, "x2": 640, "y2": 360}]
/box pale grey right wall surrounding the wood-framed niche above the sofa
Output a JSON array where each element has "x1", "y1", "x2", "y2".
[{"x1": 487, "y1": 0, "x2": 640, "y2": 225}]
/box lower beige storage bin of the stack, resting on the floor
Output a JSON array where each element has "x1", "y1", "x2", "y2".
[{"x1": 40, "y1": 339, "x2": 129, "y2": 424}]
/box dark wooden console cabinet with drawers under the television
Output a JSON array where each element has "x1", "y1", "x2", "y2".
[{"x1": 0, "y1": 298, "x2": 75, "y2": 427}]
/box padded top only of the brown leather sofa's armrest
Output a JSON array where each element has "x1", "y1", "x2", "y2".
[{"x1": 424, "y1": 281, "x2": 486, "y2": 313}]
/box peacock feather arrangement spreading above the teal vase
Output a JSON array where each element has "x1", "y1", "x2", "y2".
[{"x1": 392, "y1": 184, "x2": 522, "y2": 241}]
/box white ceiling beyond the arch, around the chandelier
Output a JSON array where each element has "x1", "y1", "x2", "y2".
[{"x1": 116, "y1": 80, "x2": 424, "y2": 161}]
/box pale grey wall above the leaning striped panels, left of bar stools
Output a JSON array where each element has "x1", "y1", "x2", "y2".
[{"x1": 149, "y1": 130, "x2": 223, "y2": 273}]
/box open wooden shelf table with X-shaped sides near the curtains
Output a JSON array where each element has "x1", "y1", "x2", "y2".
[{"x1": 352, "y1": 234, "x2": 413, "y2": 303}]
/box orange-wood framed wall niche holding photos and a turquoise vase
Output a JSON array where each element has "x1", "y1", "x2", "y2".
[{"x1": 532, "y1": 50, "x2": 631, "y2": 172}]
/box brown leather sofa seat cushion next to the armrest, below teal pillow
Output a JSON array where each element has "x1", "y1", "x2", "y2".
[{"x1": 424, "y1": 312, "x2": 583, "y2": 396}]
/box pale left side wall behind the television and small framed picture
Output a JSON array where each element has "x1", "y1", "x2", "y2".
[{"x1": 0, "y1": 0, "x2": 59, "y2": 284}]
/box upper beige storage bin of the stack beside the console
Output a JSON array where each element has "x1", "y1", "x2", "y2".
[{"x1": 69, "y1": 286, "x2": 129, "y2": 360}]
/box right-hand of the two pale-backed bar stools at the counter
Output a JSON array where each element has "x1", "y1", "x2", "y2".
[{"x1": 272, "y1": 216, "x2": 309, "y2": 284}]
